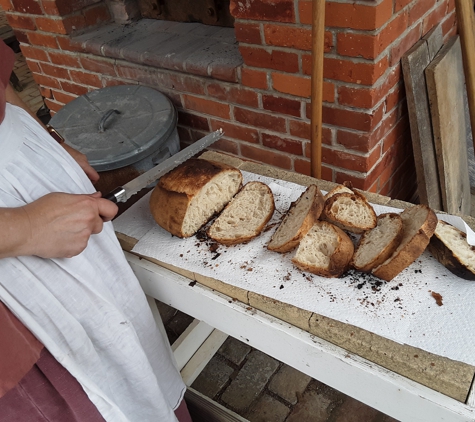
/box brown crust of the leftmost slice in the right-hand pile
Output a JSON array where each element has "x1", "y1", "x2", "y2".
[{"x1": 267, "y1": 185, "x2": 325, "y2": 253}]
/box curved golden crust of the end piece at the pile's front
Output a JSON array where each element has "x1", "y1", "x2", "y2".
[{"x1": 292, "y1": 221, "x2": 354, "y2": 278}]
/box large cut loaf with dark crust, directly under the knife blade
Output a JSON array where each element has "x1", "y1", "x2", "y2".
[{"x1": 150, "y1": 159, "x2": 242, "y2": 237}]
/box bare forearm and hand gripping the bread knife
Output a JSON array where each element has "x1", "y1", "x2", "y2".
[{"x1": 0, "y1": 192, "x2": 117, "y2": 258}]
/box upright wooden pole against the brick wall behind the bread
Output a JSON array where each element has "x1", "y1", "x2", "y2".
[{"x1": 310, "y1": 0, "x2": 325, "y2": 179}]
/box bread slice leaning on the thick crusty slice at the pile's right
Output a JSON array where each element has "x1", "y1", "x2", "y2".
[{"x1": 350, "y1": 213, "x2": 403, "y2": 272}]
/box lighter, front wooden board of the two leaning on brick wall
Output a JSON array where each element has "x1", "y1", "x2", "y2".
[{"x1": 425, "y1": 36, "x2": 471, "y2": 215}]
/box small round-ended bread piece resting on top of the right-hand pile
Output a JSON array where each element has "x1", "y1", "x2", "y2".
[{"x1": 322, "y1": 191, "x2": 376, "y2": 234}]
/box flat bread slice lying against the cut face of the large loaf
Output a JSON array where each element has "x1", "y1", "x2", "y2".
[{"x1": 207, "y1": 182, "x2": 275, "y2": 245}]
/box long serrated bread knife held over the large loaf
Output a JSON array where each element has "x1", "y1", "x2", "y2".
[{"x1": 103, "y1": 129, "x2": 224, "y2": 203}]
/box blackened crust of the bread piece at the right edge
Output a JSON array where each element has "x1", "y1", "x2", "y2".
[{"x1": 428, "y1": 221, "x2": 475, "y2": 280}]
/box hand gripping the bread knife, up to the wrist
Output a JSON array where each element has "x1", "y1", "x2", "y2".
[{"x1": 21, "y1": 192, "x2": 118, "y2": 258}]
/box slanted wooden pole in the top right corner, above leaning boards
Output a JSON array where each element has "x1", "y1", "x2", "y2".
[{"x1": 455, "y1": 0, "x2": 475, "y2": 157}]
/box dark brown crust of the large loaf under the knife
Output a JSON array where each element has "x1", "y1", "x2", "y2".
[{"x1": 149, "y1": 158, "x2": 242, "y2": 237}]
